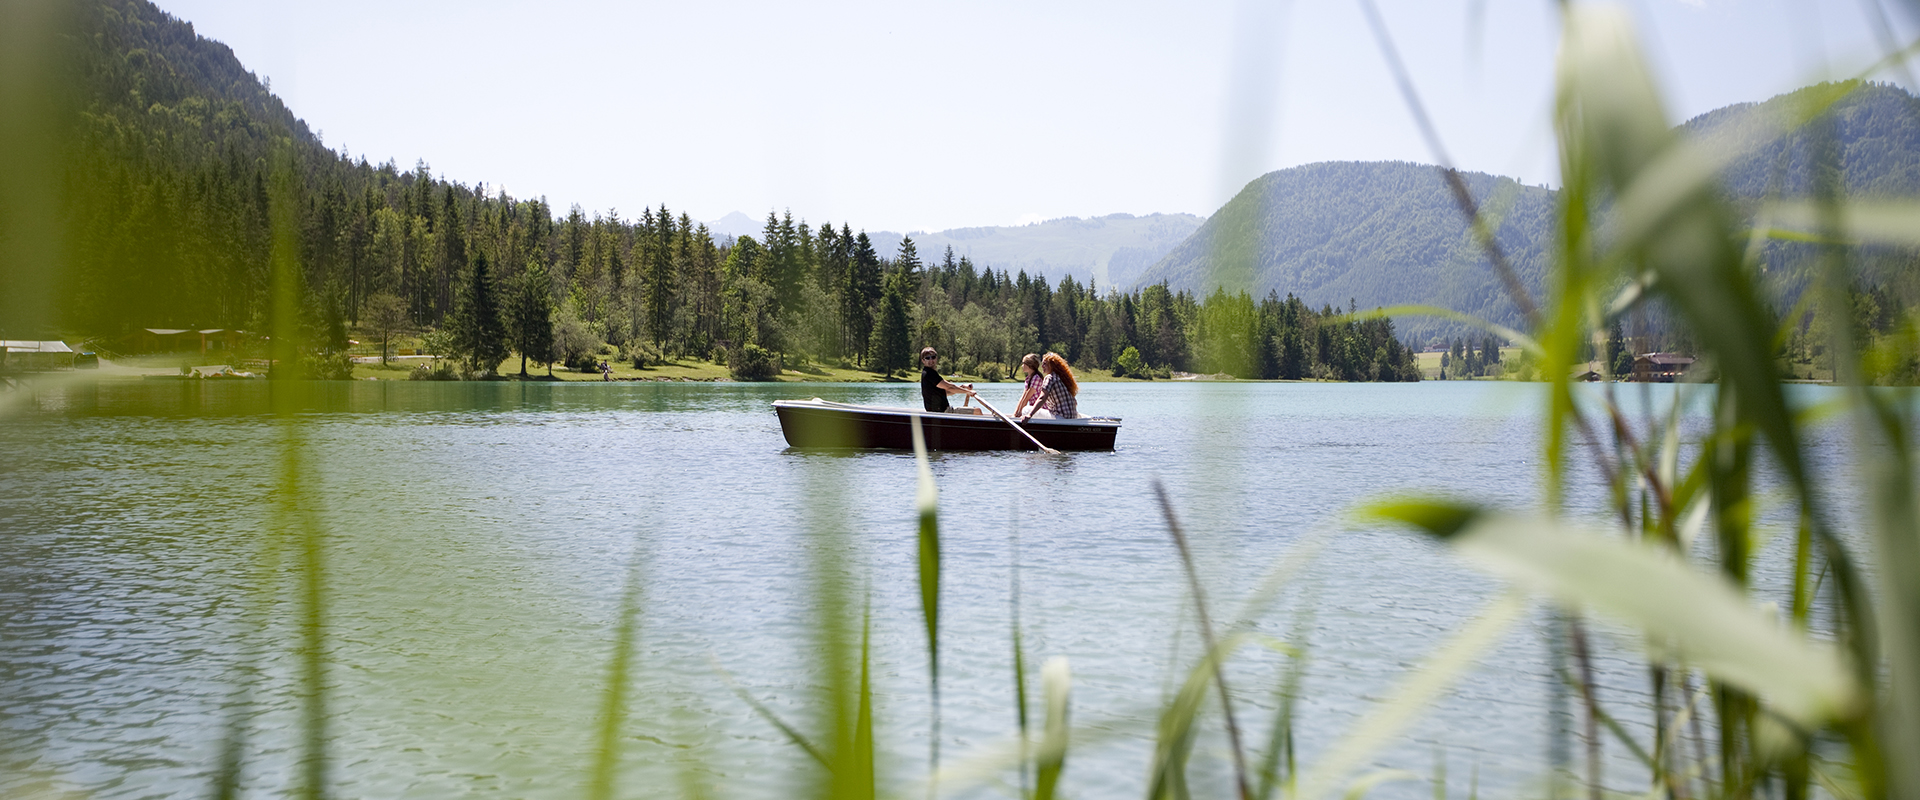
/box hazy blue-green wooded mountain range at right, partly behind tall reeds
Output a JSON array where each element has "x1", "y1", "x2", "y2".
[{"x1": 1117, "y1": 84, "x2": 1920, "y2": 341}]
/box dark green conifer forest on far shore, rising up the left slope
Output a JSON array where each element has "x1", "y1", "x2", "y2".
[{"x1": 22, "y1": 0, "x2": 1417, "y2": 380}]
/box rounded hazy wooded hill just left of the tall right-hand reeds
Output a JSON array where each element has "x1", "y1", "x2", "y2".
[{"x1": 1137, "y1": 161, "x2": 1553, "y2": 341}]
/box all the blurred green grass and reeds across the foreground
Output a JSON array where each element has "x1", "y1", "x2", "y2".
[{"x1": 0, "y1": 4, "x2": 1920, "y2": 800}]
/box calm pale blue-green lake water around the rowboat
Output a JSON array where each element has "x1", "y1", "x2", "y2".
[{"x1": 0, "y1": 382, "x2": 1881, "y2": 798}]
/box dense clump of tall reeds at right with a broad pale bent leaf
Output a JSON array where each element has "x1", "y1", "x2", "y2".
[{"x1": 1369, "y1": 4, "x2": 1920, "y2": 800}]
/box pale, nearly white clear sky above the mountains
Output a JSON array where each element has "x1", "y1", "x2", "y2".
[{"x1": 156, "y1": 0, "x2": 1914, "y2": 230}]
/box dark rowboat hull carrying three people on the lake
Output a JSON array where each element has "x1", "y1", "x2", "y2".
[{"x1": 774, "y1": 397, "x2": 1119, "y2": 451}]
